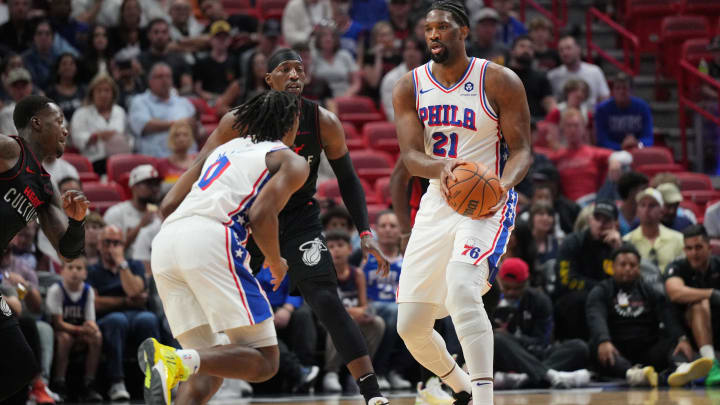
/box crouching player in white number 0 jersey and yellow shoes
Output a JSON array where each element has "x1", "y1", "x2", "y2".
[{"x1": 138, "y1": 91, "x2": 309, "y2": 405}]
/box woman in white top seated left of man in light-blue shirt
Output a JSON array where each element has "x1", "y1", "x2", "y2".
[{"x1": 70, "y1": 74, "x2": 129, "y2": 175}]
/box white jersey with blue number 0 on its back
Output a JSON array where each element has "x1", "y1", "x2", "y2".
[{"x1": 164, "y1": 138, "x2": 287, "y2": 229}]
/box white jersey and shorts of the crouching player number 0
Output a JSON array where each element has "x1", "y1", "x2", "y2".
[{"x1": 151, "y1": 138, "x2": 287, "y2": 347}]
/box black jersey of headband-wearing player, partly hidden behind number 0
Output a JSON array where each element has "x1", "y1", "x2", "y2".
[{"x1": 283, "y1": 98, "x2": 323, "y2": 212}]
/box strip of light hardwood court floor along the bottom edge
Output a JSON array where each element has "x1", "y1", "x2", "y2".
[{"x1": 211, "y1": 388, "x2": 720, "y2": 405}]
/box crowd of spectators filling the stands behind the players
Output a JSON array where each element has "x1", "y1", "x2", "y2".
[{"x1": 0, "y1": 0, "x2": 720, "y2": 403}]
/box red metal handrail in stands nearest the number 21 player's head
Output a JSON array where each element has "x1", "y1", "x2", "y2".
[{"x1": 585, "y1": 7, "x2": 640, "y2": 76}]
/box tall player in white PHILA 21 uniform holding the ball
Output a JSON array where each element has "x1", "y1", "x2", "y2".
[{"x1": 393, "y1": 0, "x2": 532, "y2": 405}]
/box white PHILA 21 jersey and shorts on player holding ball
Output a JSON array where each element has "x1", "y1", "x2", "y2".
[{"x1": 397, "y1": 58, "x2": 517, "y2": 314}]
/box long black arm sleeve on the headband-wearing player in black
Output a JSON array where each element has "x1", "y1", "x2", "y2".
[{"x1": 328, "y1": 152, "x2": 370, "y2": 232}]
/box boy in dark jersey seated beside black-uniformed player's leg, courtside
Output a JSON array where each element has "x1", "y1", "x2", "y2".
[{"x1": 323, "y1": 231, "x2": 385, "y2": 392}]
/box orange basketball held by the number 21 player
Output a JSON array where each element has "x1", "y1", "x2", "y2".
[{"x1": 448, "y1": 162, "x2": 503, "y2": 219}]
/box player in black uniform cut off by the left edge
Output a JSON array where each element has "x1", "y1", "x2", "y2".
[{"x1": 0, "y1": 96, "x2": 90, "y2": 401}]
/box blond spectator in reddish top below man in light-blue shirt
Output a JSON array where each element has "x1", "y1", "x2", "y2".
[{"x1": 158, "y1": 121, "x2": 195, "y2": 185}]
